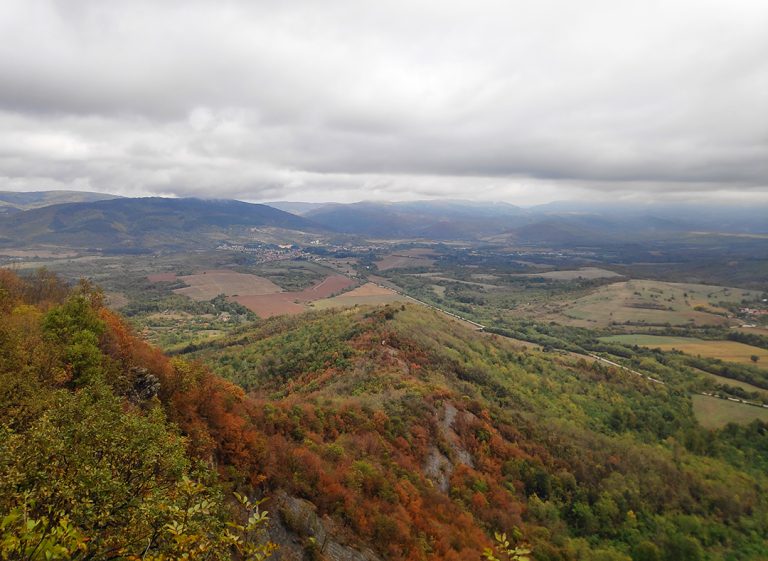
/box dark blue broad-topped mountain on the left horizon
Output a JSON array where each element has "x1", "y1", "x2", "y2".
[{"x1": 0, "y1": 197, "x2": 322, "y2": 248}]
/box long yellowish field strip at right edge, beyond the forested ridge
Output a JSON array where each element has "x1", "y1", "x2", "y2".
[{"x1": 601, "y1": 334, "x2": 768, "y2": 366}]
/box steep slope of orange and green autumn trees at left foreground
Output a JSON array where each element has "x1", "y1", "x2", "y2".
[{"x1": 0, "y1": 270, "x2": 273, "y2": 561}]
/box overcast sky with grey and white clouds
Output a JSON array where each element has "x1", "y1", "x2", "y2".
[{"x1": 0, "y1": 0, "x2": 768, "y2": 205}]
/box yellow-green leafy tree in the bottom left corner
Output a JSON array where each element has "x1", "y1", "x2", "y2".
[{"x1": 0, "y1": 383, "x2": 274, "y2": 561}]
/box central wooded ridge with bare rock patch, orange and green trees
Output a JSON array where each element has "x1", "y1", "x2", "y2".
[{"x1": 184, "y1": 306, "x2": 768, "y2": 560}]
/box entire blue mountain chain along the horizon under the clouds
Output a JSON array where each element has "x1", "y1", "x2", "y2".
[{"x1": 0, "y1": 191, "x2": 768, "y2": 249}]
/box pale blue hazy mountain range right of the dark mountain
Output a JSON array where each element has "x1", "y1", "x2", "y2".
[{"x1": 272, "y1": 201, "x2": 768, "y2": 243}]
